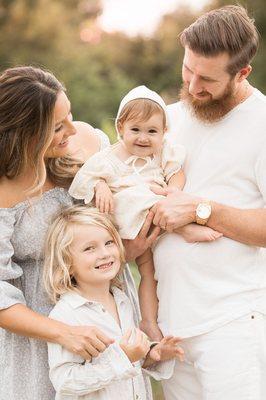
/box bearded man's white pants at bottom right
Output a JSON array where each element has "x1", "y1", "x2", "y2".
[{"x1": 162, "y1": 312, "x2": 266, "y2": 400}]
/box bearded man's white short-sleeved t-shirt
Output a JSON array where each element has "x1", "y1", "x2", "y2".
[{"x1": 153, "y1": 89, "x2": 266, "y2": 338}]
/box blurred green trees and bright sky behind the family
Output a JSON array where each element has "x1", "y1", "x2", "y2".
[{"x1": 0, "y1": 0, "x2": 266, "y2": 400}]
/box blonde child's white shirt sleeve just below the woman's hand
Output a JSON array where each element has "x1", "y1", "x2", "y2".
[{"x1": 48, "y1": 343, "x2": 141, "y2": 396}]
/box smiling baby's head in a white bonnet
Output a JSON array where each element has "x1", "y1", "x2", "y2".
[{"x1": 116, "y1": 86, "x2": 167, "y2": 157}]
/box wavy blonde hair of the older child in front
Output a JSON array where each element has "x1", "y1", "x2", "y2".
[{"x1": 44, "y1": 205, "x2": 125, "y2": 303}]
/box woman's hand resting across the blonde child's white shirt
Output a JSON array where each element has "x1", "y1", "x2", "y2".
[{"x1": 57, "y1": 325, "x2": 114, "y2": 361}]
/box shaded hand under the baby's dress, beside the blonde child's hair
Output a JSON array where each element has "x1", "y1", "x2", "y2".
[{"x1": 123, "y1": 211, "x2": 161, "y2": 261}]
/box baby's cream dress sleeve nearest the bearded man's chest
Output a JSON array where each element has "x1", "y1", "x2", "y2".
[{"x1": 162, "y1": 141, "x2": 186, "y2": 183}]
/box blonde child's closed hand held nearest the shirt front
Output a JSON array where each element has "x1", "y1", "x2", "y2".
[{"x1": 119, "y1": 328, "x2": 150, "y2": 363}]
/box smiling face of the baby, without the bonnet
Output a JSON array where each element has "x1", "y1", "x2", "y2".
[{"x1": 120, "y1": 113, "x2": 165, "y2": 157}]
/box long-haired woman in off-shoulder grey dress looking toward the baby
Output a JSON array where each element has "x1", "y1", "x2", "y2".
[{"x1": 0, "y1": 67, "x2": 157, "y2": 400}]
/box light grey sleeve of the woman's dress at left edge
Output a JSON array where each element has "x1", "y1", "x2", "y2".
[{"x1": 0, "y1": 209, "x2": 26, "y2": 310}]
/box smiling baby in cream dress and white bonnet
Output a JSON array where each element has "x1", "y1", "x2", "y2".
[{"x1": 69, "y1": 86, "x2": 220, "y2": 340}]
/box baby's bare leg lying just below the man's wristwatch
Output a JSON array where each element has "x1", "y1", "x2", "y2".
[{"x1": 177, "y1": 224, "x2": 223, "y2": 243}]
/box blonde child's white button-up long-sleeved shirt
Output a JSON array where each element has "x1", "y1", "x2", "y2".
[{"x1": 48, "y1": 287, "x2": 174, "y2": 400}]
